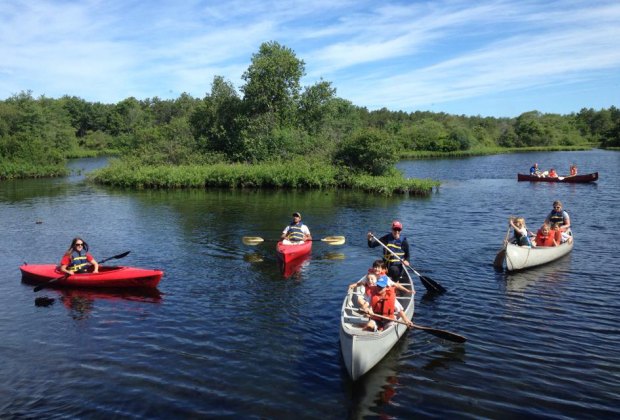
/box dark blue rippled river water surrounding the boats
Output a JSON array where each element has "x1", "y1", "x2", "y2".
[{"x1": 0, "y1": 150, "x2": 620, "y2": 419}]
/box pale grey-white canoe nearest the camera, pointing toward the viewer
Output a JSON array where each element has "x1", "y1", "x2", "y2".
[{"x1": 340, "y1": 270, "x2": 414, "y2": 380}]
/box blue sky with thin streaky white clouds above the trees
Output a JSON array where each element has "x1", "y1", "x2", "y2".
[{"x1": 0, "y1": 0, "x2": 620, "y2": 117}]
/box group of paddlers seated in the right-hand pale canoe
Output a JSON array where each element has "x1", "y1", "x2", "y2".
[{"x1": 508, "y1": 200, "x2": 573, "y2": 247}]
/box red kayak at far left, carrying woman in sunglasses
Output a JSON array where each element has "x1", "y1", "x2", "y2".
[{"x1": 19, "y1": 264, "x2": 164, "y2": 288}]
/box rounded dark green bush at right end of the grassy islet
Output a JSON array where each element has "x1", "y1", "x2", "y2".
[{"x1": 334, "y1": 129, "x2": 400, "y2": 175}]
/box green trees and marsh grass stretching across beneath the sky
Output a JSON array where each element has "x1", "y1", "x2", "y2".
[{"x1": 0, "y1": 41, "x2": 620, "y2": 178}]
